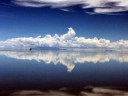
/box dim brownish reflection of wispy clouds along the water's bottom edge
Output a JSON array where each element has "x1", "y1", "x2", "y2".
[{"x1": 10, "y1": 87, "x2": 128, "y2": 96}]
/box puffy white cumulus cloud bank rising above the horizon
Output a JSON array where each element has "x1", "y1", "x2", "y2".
[{"x1": 0, "y1": 28, "x2": 128, "y2": 49}]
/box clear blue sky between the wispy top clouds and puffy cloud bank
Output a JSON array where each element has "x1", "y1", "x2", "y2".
[{"x1": 0, "y1": 1, "x2": 128, "y2": 41}]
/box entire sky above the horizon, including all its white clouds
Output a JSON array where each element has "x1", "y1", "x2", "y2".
[{"x1": 0, "y1": 0, "x2": 128, "y2": 48}]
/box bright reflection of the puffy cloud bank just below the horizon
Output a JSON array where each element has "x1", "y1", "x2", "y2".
[{"x1": 0, "y1": 50, "x2": 128, "y2": 72}]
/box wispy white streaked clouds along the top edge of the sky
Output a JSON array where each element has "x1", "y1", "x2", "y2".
[{"x1": 12, "y1": 0, "x2": 128, "y2": 14}]
